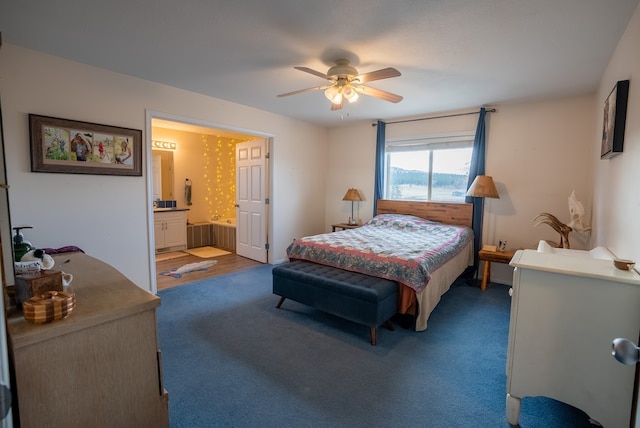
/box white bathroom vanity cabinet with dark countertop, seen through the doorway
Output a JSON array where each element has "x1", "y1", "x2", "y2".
[{"x1": 153, "y1": 208, "x2": 188, "y2": 253}]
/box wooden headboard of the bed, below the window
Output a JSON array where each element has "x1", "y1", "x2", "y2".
[{"x1": 376, "y1": 199, "x2": 473, "y2": 227}]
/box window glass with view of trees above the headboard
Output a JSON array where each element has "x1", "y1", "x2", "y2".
[{"x1": 385, "y1": 147, "x2": 472, "y2": 202}]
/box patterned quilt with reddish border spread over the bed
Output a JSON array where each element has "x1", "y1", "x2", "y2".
[{"x1": 287, "y1": 214, "x2": 473, "y2": 291}]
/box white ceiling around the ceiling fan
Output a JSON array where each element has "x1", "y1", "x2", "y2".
[{"x1": 0, "y1": 0, "x2": 640, "y2": 126}]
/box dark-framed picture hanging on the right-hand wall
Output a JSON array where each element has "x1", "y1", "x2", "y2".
[{"x1": 600, "y1": 80, "x2": 629, "y2": 159}]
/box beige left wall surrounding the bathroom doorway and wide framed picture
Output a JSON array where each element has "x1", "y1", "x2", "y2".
[{"x1": 0, "y1": 44, "x2": 327, "y2": 290}]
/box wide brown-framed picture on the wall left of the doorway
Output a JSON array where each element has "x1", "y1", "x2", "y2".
[{"x1": 29, "y1": 114, "x2": 142, "y2": 176}]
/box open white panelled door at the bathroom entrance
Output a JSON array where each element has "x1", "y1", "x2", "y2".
[{"x1": 236, "y1": 138, "x2": 267, "y2": 263}]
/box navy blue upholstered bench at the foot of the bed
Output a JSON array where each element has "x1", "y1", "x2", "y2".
[{"x1": 273, "y1": 261, "x2": 398, "y2": 345}]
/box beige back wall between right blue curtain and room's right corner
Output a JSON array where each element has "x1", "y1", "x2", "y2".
[{"x1": 485, "y1": 96, "x2": 594, "y2": 249}]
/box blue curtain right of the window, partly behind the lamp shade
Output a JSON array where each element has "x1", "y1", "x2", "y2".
[{"x1": 465, "y1": 107, "x2": 486, "y2": 272}]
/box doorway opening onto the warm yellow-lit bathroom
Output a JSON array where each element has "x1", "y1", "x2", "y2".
[{"x1": 148, "y1": 114, "x2": 271, "y2": 290}]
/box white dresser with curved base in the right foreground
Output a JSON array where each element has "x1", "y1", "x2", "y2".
[{"x1": 506, "y1": 249, "x2": 640, "y2": 428}]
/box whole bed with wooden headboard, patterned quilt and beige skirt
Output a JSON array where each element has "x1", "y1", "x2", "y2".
[{"x1": 287, "y1": 200, "x2": 473, "y2": 331}]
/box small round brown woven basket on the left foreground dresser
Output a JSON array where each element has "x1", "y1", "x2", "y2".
[{"x1": 22, "y1": 291, "x2": 76, "y2": 324}]
